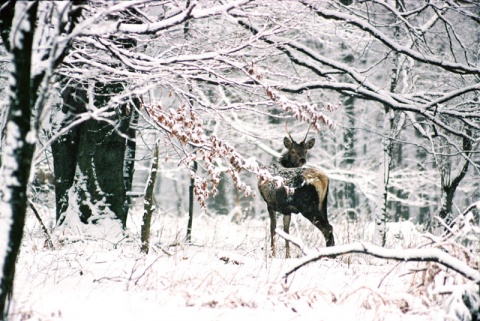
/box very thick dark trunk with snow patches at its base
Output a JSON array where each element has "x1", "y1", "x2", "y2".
[{"x1": 52, "y1": 83, "x2": 138, "y2": 227}]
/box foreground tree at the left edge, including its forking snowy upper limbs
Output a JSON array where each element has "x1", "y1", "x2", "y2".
[{"x1": 0, "y1": 1, "x2": 82, "y2": 319}]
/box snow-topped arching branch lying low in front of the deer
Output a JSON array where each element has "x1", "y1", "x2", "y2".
[{"x1": 284, "y1": 239, "x2": 480, "y2": 284}]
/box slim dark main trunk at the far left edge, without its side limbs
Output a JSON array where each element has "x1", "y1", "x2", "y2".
[{"x1": 0, "y1": 2, "x2": 38, "y2": 320}]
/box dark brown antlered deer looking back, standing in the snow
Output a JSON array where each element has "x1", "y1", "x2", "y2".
[{"x1": 258, "y1": 124, "x2": 335, "y2": 258}]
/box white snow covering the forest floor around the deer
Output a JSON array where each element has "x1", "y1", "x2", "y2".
[{"x1": 10, "y1": 201, "x2": 480, "y2": 321}]
